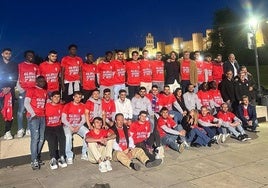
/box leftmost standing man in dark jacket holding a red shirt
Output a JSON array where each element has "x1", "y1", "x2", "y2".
[{"x1": 0, "y1": 48, "x2": 17, "y2": 140}]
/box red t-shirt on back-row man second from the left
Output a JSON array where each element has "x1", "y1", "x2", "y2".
[{"x1": 18, "y1": 62, "x2": 40, "y2": 90}]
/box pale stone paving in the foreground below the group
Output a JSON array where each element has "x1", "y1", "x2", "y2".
[{"x1": 0, "y1": 122, "x2": 268, "y2": 188}]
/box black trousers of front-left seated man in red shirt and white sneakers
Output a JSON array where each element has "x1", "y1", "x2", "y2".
[{"x1": 45, "y1": 126, "x2": 66, "y2": 158}]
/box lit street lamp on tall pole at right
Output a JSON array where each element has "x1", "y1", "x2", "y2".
[{"x1": 249, "y1": 18, "x2": 262, "y2": 99}]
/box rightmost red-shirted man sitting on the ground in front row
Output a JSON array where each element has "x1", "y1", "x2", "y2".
[{"x1": 217, "y1": 103, "x2": 250, "y2": 141}]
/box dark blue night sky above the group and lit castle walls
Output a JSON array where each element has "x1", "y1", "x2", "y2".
[{"x1": 0, "y1": 0, "x2": 268, "y2": 61}]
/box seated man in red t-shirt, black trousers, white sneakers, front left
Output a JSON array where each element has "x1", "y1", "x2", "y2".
[{"x1": 45, "y1": 91, "x2": 67, "y2": 170}]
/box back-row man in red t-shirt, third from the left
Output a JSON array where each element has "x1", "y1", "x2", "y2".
[{"x1": 39, "y1": 50, "x2": 61, "y2": 95}]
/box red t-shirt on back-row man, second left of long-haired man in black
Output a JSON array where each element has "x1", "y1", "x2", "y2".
[{"x1": 140, "y1": 59, "x2": 152, "y2": 82}]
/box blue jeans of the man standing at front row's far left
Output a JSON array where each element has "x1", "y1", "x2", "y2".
[{"x1": 27, "y1": 117, "x2": 46, "y2": 161}]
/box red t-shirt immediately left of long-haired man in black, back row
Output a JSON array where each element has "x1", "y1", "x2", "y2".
[{"x1": 152, "y1": 60, "x2": 165, "y2": 82}]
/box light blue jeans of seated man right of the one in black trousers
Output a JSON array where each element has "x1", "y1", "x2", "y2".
[{"x1": 63, "y1": 126, "x2": 89, "y2": 159}]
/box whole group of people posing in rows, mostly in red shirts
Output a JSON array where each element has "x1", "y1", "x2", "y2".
[{"x1": 0, "y1": 44, "x2": 258, "y2": 172}]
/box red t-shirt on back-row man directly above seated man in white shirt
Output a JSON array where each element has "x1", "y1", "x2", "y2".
[{"x1": 111, "y1": 59, "x2": 126, "y2": 84}]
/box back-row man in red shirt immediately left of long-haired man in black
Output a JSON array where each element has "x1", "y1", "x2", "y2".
[{"x1": 152, "y1": 52, "x2": 165, "y2": 91}]
